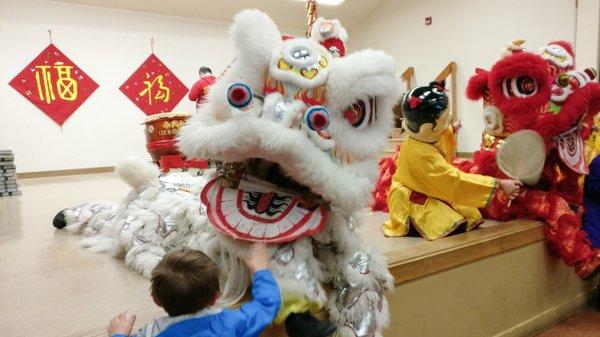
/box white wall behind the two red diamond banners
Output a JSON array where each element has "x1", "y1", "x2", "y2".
[{"x1": 0, "y1": 0, "x2": 233, "y2": 172}]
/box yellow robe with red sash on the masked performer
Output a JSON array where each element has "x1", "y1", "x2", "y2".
[{"x1": 383, "y1": 137, "x2": 498, "y2": 240}]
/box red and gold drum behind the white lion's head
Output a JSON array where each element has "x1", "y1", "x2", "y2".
[{"x1": 144, "y1": 112, "x2": 191, "y2": 164}]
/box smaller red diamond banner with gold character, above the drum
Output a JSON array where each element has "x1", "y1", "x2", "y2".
[{"x1": 119, "y1": 54, "x2": 188, "y2": 115}]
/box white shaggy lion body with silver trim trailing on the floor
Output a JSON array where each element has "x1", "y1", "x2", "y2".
[{"x1": 62, "y1": 159, "x2": 210, "y2": 277}]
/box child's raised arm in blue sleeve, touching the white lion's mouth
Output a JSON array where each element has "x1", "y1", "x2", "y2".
[{"x1": 237, "y1": 243, "x2": 281, "y2": 337}]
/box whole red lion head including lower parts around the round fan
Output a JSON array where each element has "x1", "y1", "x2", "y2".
[{"x1": 463, "y1": 41, "x2": 600, "y2": 205}]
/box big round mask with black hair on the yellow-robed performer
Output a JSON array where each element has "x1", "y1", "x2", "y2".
[{"x1": 402, "y1": 82, "x2": 452, "y2": 143}]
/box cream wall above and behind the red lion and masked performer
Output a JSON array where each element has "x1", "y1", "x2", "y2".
[{"x1": 350, "y1": 0, "x2": 598, "y2": 152}]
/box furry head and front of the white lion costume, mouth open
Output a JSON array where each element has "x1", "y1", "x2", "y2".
[{"x1": 54, "y1": 10, "x2": 401, "y2": 337}]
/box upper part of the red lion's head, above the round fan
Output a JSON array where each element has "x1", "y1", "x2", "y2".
[{"x1": 467, "y1": 41, "x2": 600, "y2": 147}]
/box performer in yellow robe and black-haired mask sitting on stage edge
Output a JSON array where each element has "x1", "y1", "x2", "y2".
[{"x1": 383, "y1": 82, "x2": 521, "y2": 240}]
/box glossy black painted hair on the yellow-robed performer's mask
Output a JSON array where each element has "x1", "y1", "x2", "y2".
[{"x1": 402, "y1": 81, "x2": 448, "y2": 133}]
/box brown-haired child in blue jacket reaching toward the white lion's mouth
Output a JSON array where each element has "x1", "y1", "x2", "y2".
[{"x1": 108, "y1": 243, "x2": 281, "y2": 337}]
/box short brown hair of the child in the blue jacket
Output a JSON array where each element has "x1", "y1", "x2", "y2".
[{"x1": 151, "y1": 248, "x2": 220, "y2": 316}]
